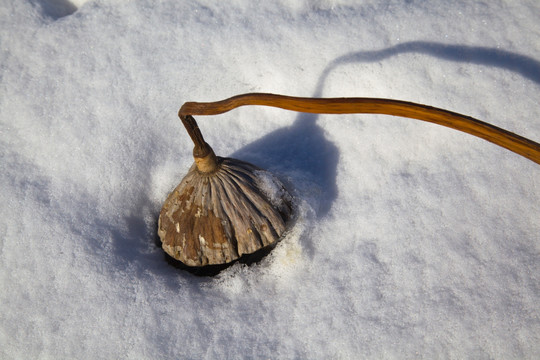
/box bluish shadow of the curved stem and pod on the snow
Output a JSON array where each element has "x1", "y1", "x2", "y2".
[{"x1": 232, "y1": 41, "x2": 540, "y2": 217}]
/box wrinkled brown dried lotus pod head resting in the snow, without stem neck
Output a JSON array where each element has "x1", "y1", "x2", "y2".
[{"x1": 158, "y1": 158, "x2": 292, "y2": 266}]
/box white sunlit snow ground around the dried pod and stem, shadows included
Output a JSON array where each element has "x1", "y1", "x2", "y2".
[{"x1": 0, "y1": 0, "x2": 540, "y2": 359}]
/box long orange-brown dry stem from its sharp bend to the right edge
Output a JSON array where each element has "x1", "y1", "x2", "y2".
[{"x1": 178, "y1": 93, "x2": 540, "y2": 164}]
